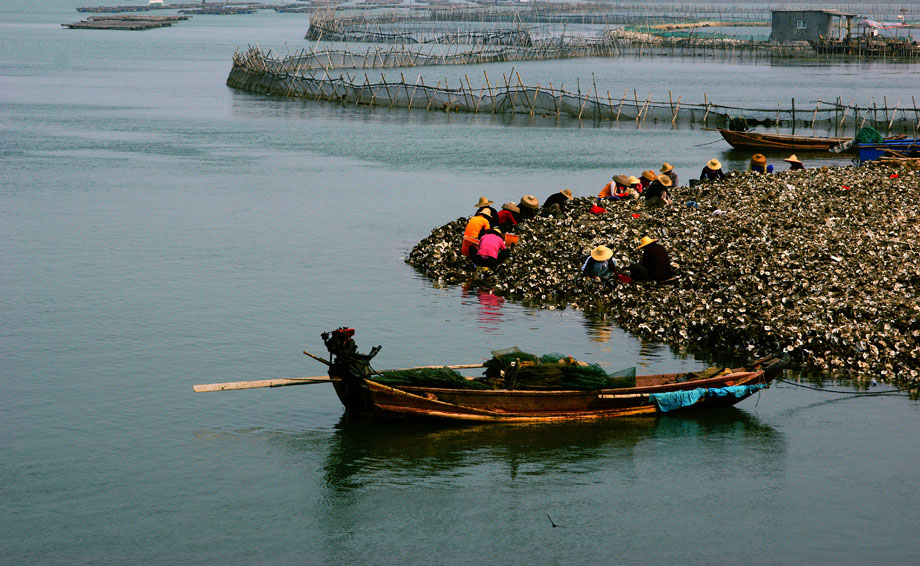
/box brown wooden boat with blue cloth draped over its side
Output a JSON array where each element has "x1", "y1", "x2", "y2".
[{"x1": 311, "y1": 329, "x2": 786, "y2": 422}]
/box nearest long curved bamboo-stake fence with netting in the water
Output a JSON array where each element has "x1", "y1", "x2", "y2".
[{"x1": 227, "y1": 47, "x2": 920, "y2": 133}]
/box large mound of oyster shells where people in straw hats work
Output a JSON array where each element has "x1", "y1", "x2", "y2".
[{"x1": 406, "y1": 163, "x2": 920, "y2": 384}]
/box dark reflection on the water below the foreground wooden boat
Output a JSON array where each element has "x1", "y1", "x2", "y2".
[{"x1": 312, "y1": 407, "x2": 784, "y2": 492}]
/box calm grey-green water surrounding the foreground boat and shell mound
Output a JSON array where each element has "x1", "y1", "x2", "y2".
[{"x1": 0, "y1": 0, "x2": 920, "y2": 564}]
